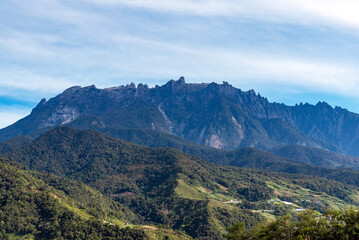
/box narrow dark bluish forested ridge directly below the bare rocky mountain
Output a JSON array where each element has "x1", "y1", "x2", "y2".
[{"x1": 69, "y1": 119, "x2": 359, "y2": 186}]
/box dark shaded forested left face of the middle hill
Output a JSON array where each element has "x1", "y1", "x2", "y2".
[{"x1": 9, "y1": 128, "x2": 259, "y2": 238}]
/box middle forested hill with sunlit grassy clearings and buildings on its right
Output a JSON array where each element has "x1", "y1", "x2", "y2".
[{"x1": 7, "y1": 127, "x2": 359, "y2": 239}]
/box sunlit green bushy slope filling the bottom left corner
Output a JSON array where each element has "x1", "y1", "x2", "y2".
[{"x1": 0, "y1": 158, "x2": 146, "y2": 239}]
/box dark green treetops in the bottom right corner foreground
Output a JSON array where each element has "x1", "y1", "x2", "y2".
[{"x1": 227, "y1": 209, "x2": 359, "y2": 240}]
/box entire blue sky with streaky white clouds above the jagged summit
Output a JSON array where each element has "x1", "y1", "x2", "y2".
[{"x1": 0, "y1": 0, "x2": 359, "y2": 127}]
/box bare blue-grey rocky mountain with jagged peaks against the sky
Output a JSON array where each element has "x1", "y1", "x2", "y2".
[{"x1": 0, "y1": 78, "x2": 359, "y2": 155}]
